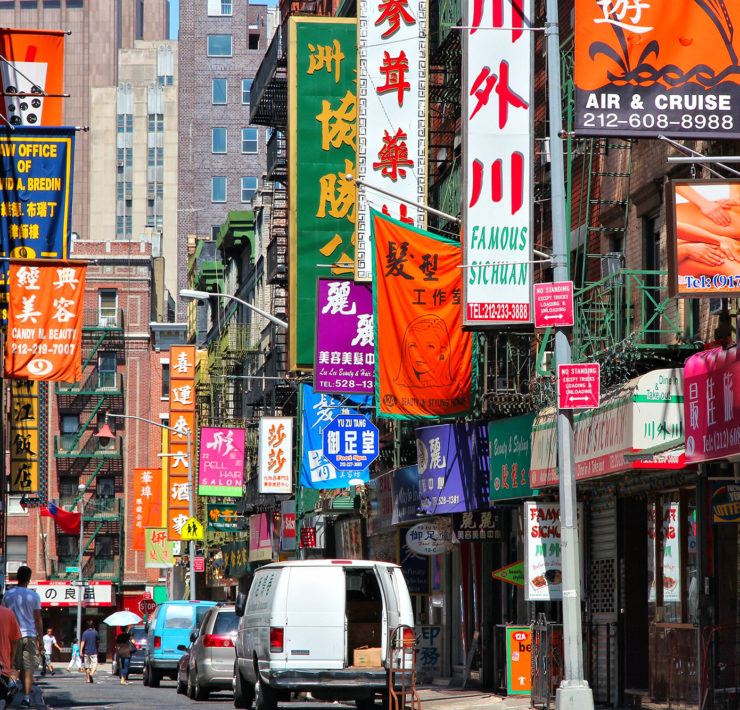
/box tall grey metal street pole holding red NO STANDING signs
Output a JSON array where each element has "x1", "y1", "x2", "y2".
[{"x1": 545, "y1": 0, "x2": 594, "y2": 710}]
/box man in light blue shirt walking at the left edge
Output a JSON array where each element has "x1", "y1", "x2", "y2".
[{"x1": 3, "y1": 565, "x2": 44, "y2": 708}]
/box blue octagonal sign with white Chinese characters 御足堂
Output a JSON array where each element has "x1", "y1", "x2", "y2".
[{"x1": 323, "y1": 414, "x2": 380, "y2": 471}]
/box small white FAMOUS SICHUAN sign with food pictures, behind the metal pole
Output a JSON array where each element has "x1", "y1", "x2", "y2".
[{"x1": 524, "y1": 501, "x2": 584, "y2": 602}]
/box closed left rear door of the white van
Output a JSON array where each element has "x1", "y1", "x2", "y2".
[{"x1": 284, "y1": 565, "x2": 345, "y2": 670}]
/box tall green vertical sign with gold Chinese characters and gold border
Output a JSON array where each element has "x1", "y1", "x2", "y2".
[{"x1": 288, "y1": 17, "x2": 357, "y2": 370}]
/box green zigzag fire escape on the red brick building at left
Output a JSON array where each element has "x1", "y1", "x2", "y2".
[{"x1": 51, "y1": 307, "x2": 126, "y2": 588}]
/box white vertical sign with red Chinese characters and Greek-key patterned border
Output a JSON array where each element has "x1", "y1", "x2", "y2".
[{"x1": 355, "y1": 0, "x2": 427, "y2": 281}]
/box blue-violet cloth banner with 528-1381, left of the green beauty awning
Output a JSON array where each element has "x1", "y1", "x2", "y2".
[{"x1": 416, "y1": 422, "x2": 490, "y2": 515}]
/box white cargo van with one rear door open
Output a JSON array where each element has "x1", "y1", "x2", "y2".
[{"x1": 234, "y1": 560, "x2": 413, "y2": 710}]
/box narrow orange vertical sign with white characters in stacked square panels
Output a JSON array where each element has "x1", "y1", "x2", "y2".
[{"x1": 167, "y1": 345, "x2": 195, "y2": 540}]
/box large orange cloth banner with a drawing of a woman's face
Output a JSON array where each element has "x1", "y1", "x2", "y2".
[{"x1": 372, "y1": 210, "x2": 475, "y2": 419}]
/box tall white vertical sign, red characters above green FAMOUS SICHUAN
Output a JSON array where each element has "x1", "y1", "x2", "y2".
[{"x1": 462, "y1": 0, "x2": 534, "y2": 326}]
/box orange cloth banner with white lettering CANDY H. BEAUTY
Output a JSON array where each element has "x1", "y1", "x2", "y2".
[{"x1": 5, "y1": 259, "x2": 87, "y2": 382}]
